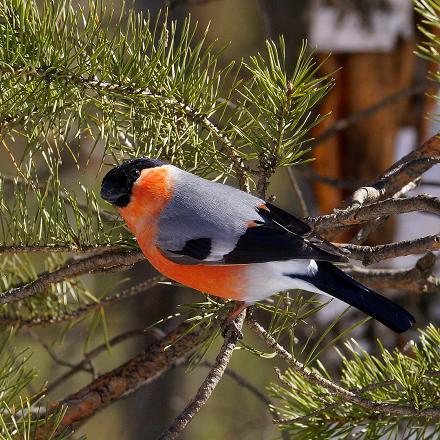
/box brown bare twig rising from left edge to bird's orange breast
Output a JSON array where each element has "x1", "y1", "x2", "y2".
[{"x1": 0, "y1": 251, "x2": 145, "y2": 304}]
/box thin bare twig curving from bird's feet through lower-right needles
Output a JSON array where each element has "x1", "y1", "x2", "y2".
[{"x1": 247, "y1": 320, "x2": 440, "y2": 419}]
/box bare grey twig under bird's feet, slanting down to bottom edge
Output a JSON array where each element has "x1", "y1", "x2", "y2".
[{"x1": 159, "y1": 312, "x2": 245, "y2": 440}]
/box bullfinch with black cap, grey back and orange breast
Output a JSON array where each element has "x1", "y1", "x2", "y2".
[{"x1": 101, "y1": 157, "x2": 415, "y2": 333}]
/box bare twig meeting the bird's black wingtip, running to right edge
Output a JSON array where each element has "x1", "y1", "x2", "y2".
[{"x1": 338, "y1": 235, "x2": 440, "y2": 266}]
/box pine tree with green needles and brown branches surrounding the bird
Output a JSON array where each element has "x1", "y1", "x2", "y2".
[{"x1": 0, "y1": 0, "x2": 440, "y2": 439}]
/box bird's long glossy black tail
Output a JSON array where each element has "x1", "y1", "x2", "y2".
[{"x1": 296, "y1": 261, "x2": 415, "y2": 333}]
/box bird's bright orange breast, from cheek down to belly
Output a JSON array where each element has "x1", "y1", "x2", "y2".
[{"x1": 119, "y1": 166, "x2": 246, "y2": 300}]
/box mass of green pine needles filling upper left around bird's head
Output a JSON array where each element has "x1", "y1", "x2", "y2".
[{"x1": 0, "y1": 0, "x2": 330, "y2": 348}]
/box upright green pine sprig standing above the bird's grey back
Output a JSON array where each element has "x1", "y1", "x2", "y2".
[{"x1": 233, "y1": 37, "x2": 332, "y2": 169}]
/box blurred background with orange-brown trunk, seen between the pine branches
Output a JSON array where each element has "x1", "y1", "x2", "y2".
[{"x1": 2, "y1": 0, "x2": 440, "y2": 440}]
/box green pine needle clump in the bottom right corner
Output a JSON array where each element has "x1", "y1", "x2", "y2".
[{"x1": 270, "y1": 326, "x2": 440, "y2": 440}]
